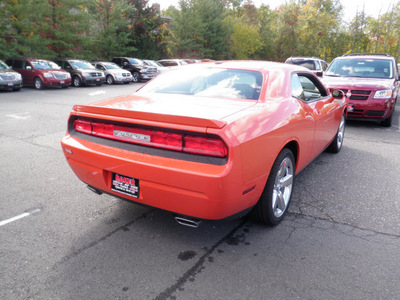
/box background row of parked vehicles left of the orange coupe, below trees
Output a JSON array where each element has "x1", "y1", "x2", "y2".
[{"x1": 0, "y1": 57, "x2": 203, "y2": 91}]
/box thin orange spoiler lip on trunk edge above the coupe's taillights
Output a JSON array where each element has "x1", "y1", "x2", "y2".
[{"x1": 72, "y1": 105, "x2": 227, "y2": 129}]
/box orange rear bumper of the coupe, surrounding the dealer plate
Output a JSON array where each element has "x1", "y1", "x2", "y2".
[{"x1": 61, "y1": 135, "x2": 263, "y2": 220}]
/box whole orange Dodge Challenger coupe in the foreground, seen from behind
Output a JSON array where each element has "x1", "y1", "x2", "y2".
[{"x1": 61, "y1": 61, "x2": 347, "y2": 227}]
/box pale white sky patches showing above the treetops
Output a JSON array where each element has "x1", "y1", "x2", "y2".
[{"x1": 149, "y1": 0, "x2": 398, "y2": 20}]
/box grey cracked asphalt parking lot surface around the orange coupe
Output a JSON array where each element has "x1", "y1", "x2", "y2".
[{"x1": 0, "y1": 84, "x2": 400, "y2": 300}]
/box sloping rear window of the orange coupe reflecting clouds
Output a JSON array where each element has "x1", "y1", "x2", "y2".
[{"x1": 138, "y1": 67, "x2": 263, "y2": 100}]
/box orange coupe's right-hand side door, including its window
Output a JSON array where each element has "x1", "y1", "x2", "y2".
[{"x1": 296, "y1": 73, "x2": 343, "y2": 157}]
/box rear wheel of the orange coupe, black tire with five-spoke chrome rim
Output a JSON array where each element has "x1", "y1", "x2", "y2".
[{"x1": 252, "y1": 148, "x2": 295, "y2": 226}]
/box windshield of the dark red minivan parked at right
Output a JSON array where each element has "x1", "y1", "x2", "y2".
[{"x1": 326, "y1": 58, "x2": 393, "y2": 78}]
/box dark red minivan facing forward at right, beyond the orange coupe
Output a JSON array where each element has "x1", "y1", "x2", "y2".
[{"x1": 323, "y1": 53, "x2": 400, "y2": 127}]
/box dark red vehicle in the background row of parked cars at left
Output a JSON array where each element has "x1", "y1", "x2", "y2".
[{"x1": 6, "y1": 58, "x2": 71, "y2": 90}]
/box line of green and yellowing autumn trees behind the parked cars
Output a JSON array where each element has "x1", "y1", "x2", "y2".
[{"x1": 0, "y1": 0, "x2": 400, "y2": 61}]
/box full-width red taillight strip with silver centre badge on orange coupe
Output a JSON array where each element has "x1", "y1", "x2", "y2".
[{"x1": 73, "y1": 119, "x2": 228, "y2": 157}]
